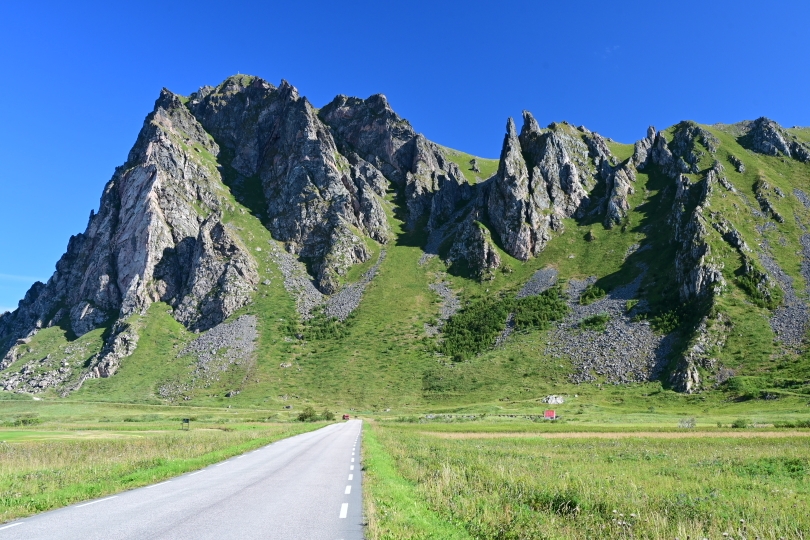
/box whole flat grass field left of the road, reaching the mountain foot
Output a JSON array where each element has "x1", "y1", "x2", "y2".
[{"x1": 0, "y1": 400, "x2": 324, "y2": 522}]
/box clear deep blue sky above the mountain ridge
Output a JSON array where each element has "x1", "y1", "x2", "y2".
[{"x1": 0, "y1": 0, "x2": 810, "y2": 311}]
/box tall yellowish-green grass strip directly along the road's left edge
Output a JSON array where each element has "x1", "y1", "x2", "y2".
[{"x1": 0, "y1": 423, "x2": 324, "y2": 523}]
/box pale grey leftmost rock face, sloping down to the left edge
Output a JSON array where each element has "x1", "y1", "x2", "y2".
[{"x1": 0, "y1": 86, "x2": 258, "y2": 376}]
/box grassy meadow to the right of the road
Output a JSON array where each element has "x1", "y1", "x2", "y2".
[{"x1": 364, "y1": 421, "x2": 810, "y2": 540}]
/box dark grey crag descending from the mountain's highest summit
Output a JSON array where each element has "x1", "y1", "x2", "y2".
[{"x1": 190, "y1": 77, "x2": 389, "y2": 294}]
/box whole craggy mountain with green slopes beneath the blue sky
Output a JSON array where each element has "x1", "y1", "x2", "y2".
[{"x1": 0, "y1": 75, "x2": 810, "y2": 407}]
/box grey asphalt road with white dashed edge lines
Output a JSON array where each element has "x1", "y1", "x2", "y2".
[{"x1": 0, "y1": 420, "x2": 363, "y2": 540}]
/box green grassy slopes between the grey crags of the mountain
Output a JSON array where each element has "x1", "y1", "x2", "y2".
[{"x1": 4, "y1": 117, "x2": 810, "y2": 411}]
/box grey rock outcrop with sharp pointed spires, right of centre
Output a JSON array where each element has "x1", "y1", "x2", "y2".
[{"x1": 487, "y1": 115, "x2": 636, "y2": 260}]
